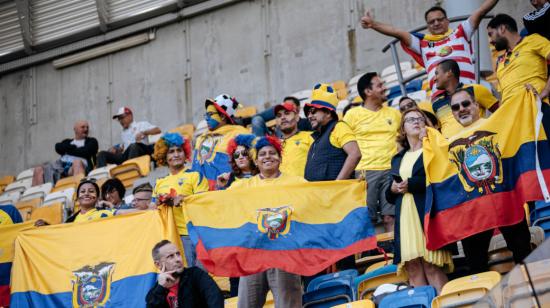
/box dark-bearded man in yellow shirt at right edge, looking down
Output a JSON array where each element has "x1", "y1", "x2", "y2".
[{"x1": 487, "y1": 14, "x2": 550, "y2": 104}]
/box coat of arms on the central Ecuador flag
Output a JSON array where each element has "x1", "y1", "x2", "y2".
[{"x1": 257, "y1": 206, "x2": 293, "y2": 240}]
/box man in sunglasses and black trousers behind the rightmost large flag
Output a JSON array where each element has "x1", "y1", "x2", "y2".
[{"x1": 451, "y1": 89, "x2": 531, "y2": 273}]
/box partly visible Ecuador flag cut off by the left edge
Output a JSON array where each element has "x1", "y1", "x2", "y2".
[{"x1": 0, "y1": 220, "x2": 34, "y2": 307}]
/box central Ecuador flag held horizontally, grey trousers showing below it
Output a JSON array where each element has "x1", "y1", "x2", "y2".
[{"x1": 188, "y1": 180, "x2": 376, "y2": 277}]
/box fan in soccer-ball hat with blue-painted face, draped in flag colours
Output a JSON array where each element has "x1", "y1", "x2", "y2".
[{"x1": 191, "y1": 94, "x2": 249, "y2": 190}]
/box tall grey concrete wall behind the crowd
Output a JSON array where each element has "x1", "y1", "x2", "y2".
[{"x1": 0, "y1": 0, "x2": 531, "y2": 175}]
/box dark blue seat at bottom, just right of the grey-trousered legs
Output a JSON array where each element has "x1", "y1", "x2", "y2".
[{"x1": 302, "y1": 270, "x2": 357, "y2": 307}]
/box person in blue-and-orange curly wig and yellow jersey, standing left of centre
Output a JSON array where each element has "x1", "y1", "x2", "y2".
[{"x1": 153, "y1": 133, "x2": 208, "y2": 266}]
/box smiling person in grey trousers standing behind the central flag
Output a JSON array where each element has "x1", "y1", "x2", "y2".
[{"x1": 229, "y1": 136, "x2": 305, "y2": 307}]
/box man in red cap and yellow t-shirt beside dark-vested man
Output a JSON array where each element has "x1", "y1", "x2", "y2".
[{"x1": 275, "y1": 100, "x2": 313, "y2": 177}]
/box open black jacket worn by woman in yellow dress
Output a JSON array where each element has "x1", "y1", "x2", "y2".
[{"x1": 386, "y1": 150, "x2": 426, "y2": 264}]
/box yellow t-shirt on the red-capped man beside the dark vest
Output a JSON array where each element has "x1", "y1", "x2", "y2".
[{"x1": 280, "y1": 131, "x2": 313, "y2": 177}]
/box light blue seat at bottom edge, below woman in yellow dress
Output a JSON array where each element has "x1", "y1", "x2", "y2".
[{"x1": 378, "y1": 286, "x2": 436, "y2": 308}]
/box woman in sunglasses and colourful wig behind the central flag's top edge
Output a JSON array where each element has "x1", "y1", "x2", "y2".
[{"x1": 216, "y1": 134, "x2": 258, "y2": 189}]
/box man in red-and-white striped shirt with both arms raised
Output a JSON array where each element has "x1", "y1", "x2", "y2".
[{"x1": 361, "y1": 0, "x2": 498, "y2": 94}]
